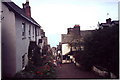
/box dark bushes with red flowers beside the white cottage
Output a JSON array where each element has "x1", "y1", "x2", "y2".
[{"x1": 15, "y1": 46, "x2": 56, "y2": 79}]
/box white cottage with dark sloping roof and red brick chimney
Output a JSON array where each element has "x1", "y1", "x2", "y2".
[{"x1": 1, "y1": 0, "x2": 41, "y2": 78}]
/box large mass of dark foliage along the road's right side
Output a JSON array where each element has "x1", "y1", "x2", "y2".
[{"x1": 76, "y1": 26, "x2": 119, "y2": 76}]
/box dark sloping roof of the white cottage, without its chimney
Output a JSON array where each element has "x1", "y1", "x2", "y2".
[{"x1": 2, "y1": 2, "x2": 41, "y2": 27}]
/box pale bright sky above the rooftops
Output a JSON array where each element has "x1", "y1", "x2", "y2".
[{"x1": 12, "y1": 0, "x2": 118, "y2": 47}]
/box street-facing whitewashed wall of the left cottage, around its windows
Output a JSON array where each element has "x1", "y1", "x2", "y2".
[{"x1": 16, "y1": 16, "x2": 41, "y2": 71}]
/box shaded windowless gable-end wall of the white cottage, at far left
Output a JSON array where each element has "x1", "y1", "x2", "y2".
[{"x1": 1, "y1": 4, "x2": 16, "y2": 77}]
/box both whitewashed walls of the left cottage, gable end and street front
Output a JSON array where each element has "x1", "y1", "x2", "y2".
[{"x1": 1, "y1": 4, "x2": 41, "y2": 77}]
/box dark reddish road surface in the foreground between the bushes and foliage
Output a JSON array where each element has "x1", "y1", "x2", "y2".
[{"x1": 56, "y1": 63, "x2": 102, "y2": 79}]
